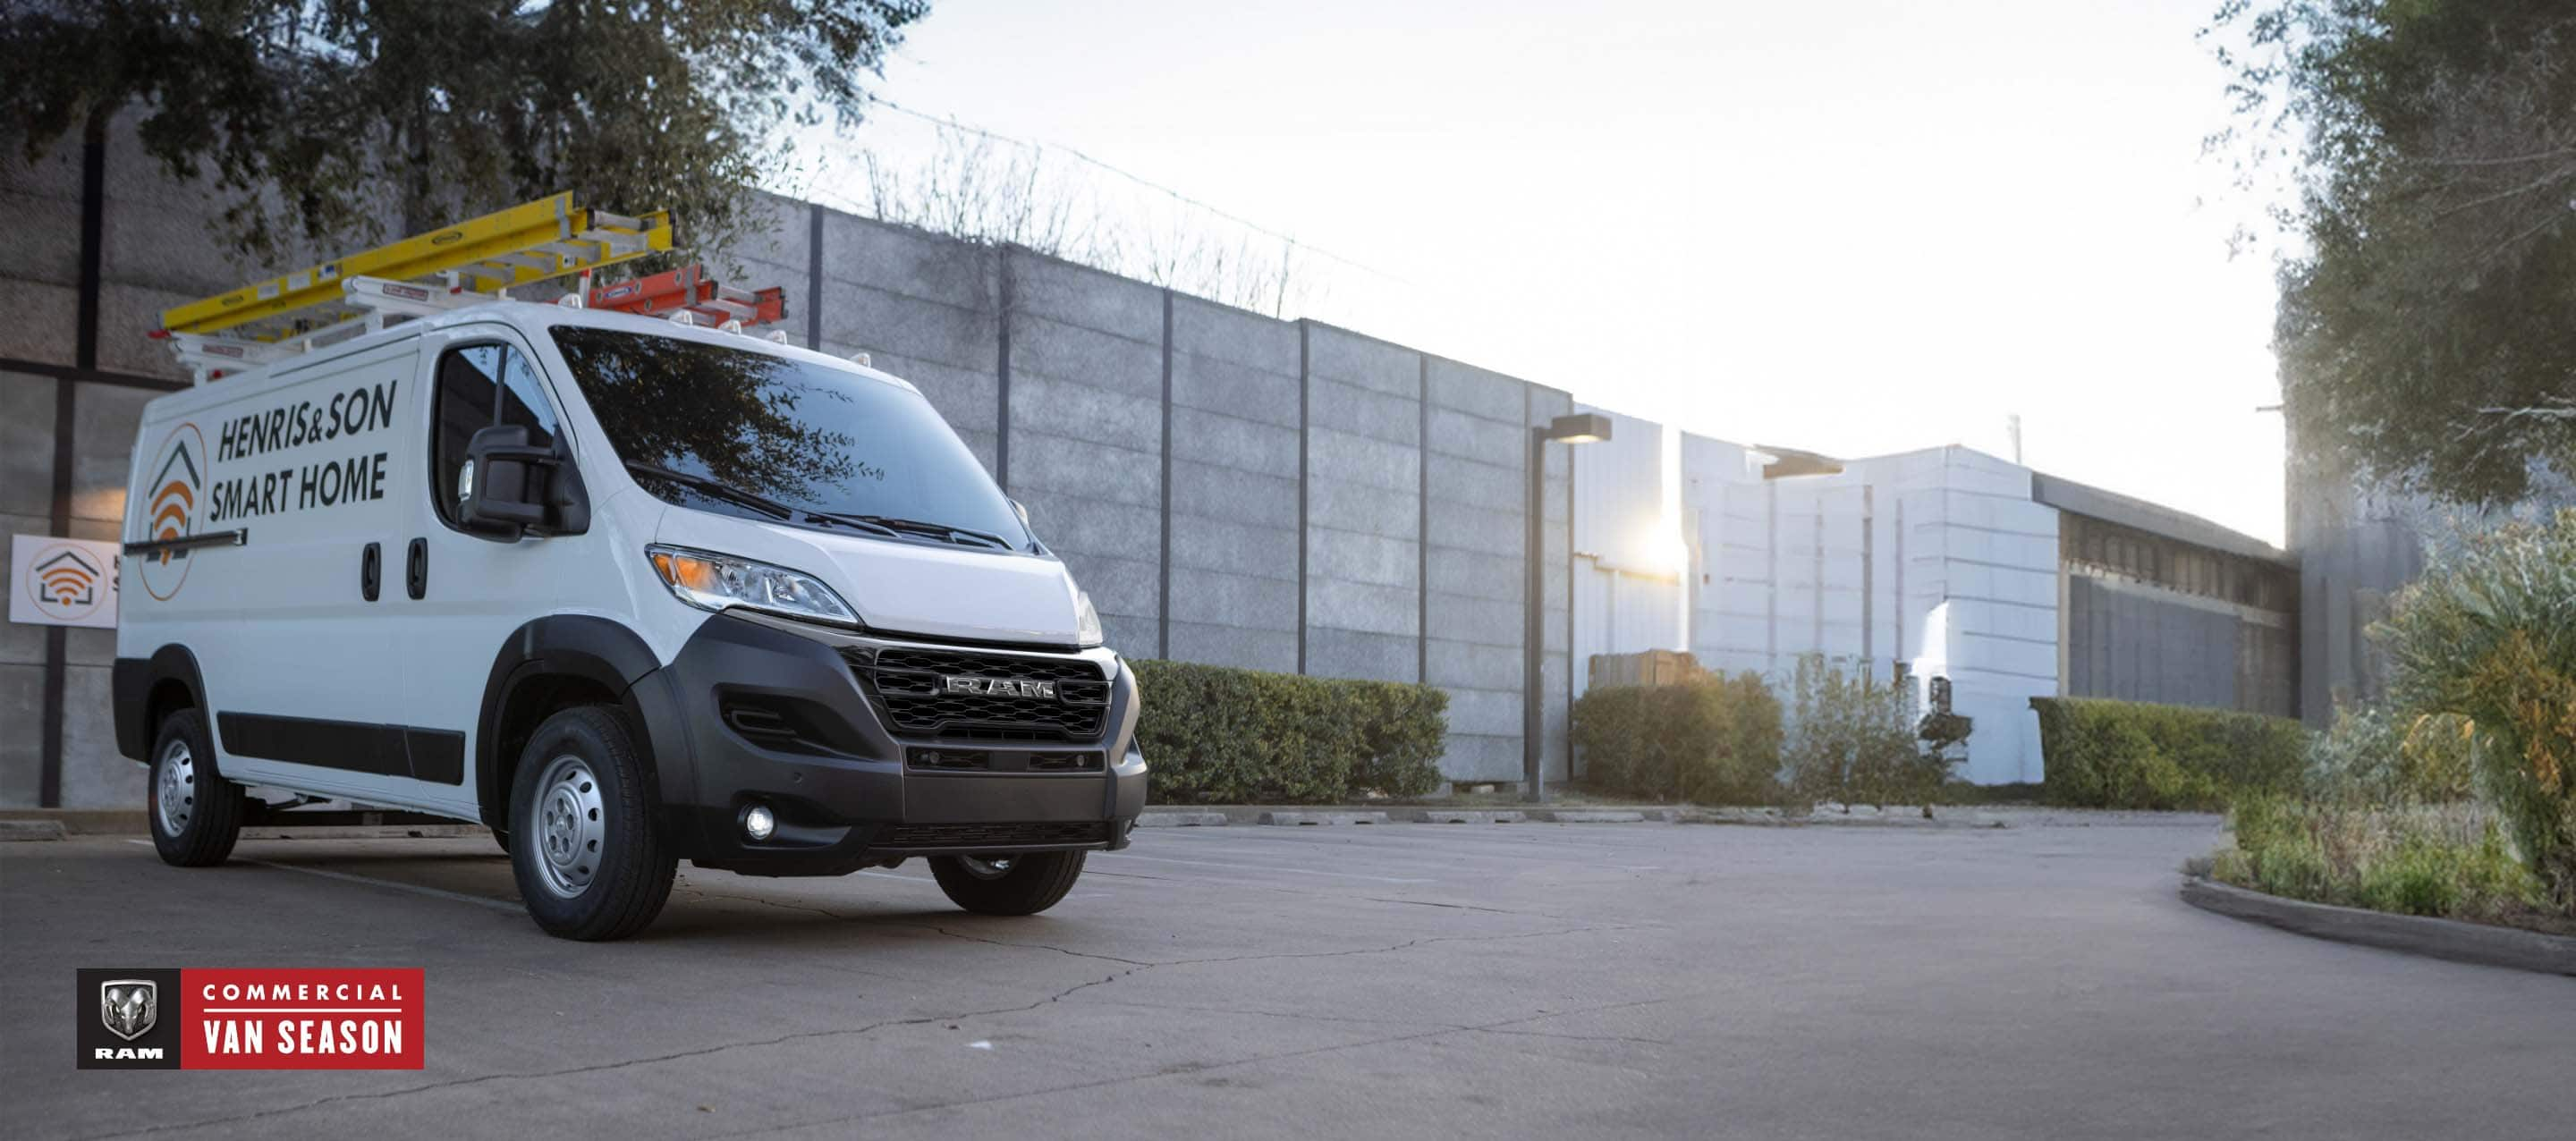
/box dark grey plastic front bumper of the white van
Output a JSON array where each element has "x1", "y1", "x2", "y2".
[{"x1": 629, "y1": 613, "x2": 1147, "y2": 875}]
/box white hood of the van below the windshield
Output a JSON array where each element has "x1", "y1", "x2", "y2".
[{"x1": 655, "y1": 507, "x2": 1082, "y2": 647}]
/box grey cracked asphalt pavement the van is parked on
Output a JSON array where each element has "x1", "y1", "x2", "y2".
[{"x1": 0, "y1": 816, "x2": 2576, "y2": 1141}]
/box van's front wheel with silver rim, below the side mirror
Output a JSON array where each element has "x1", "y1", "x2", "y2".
[{"x1": 507, "y1": 706, "x2": 677, "y2": 940}]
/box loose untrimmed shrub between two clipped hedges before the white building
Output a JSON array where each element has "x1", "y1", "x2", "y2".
[{"x1": 1783, "y1": 655, "x2": 1968, "y2": 807}]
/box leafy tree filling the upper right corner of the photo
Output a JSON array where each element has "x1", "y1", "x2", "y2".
[{"x1": 2210, "y1": 0, "x2": 2576, "y2": 505}]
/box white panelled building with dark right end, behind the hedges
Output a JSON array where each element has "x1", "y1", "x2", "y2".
[{"x1": 1574, "y1": 418, "x2": 2298, "y2": 783}]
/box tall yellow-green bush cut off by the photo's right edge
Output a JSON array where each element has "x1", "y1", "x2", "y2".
[{"x1": 2372, "y1": 510, "x2": 2576, "y2": 915}]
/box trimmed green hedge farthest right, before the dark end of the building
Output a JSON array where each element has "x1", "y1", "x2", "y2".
[{"x1": 2029, "y1": 698, "x2": 2308, "y2": 811}]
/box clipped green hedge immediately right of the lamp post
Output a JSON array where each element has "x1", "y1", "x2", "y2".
[{"x1": 1574, "y1": 672, "x2": 1780, "y2": 804}]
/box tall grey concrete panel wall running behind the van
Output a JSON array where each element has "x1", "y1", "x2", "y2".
[{"x1": 0, "y1": 131, "x2": 1574, "y2": 807}]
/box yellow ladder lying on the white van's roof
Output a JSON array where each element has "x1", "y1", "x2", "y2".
[{"x1": 155, "y1": 193, "x2": 674, "y2": 384}]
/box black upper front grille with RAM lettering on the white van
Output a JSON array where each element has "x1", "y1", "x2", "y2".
[{"x1": 843, "y1": 647, "x2": 1110, "y2": 742}]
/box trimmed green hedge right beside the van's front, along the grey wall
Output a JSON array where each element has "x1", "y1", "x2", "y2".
[{"x1": 1128, "y1": 659, "x2": 1448, "y2": 804}]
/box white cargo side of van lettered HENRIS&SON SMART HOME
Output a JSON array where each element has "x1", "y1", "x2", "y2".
[{"x1": 118, "y1": 340, "x2": 437, "y2": 804}]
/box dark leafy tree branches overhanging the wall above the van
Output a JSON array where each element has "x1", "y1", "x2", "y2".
[{"x1": 0, "y1": 0, "x2": 928, "y2": 260}]
